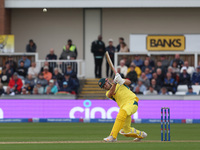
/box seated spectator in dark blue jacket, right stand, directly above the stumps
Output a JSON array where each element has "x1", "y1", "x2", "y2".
[{"x1": 163, "y1": 72, "x2": 177, "y2": 94}]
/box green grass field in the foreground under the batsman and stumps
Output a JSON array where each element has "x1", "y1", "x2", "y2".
[{"x1": 0, "y1": 123, "x2": 200, "y2": 150}]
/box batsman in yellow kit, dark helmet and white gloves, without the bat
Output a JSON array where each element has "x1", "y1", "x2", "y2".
[{"x1": 98, "y1": 73, "x2": 147, "y2": 142}]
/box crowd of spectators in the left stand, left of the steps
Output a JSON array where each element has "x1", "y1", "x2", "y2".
[{"x1": 0, "y1": 39, "x2": 79, "y2": 95}]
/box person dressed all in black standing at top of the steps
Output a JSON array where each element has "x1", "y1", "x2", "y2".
[{"x1": 91, "y1": 35, "x2": 106, "y2": 78}]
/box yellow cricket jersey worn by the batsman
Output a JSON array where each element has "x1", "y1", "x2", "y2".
[{"x1": 106, "y1": 84, "x2": 139, "y2": 108}]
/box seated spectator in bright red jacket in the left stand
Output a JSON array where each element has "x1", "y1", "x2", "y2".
[{"x1": 6, "y1": 72, "x2": 23, "y2": 94}]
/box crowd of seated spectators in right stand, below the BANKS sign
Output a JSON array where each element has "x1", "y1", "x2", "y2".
[{"x1": 118, "y1": 54, "x2": 200, "y2": 95}]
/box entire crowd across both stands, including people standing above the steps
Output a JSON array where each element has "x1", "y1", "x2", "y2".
[{"x1": 0, "y1": 36, "x2": 200, "y2": 95}]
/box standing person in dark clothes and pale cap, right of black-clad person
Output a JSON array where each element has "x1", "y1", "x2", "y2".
[{"x1": 106, "y1": 39, "x2": 116, "y2": 77}]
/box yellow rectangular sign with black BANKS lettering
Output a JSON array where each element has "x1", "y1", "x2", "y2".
[{"x1": 146, "y1": 35, "x2": 185, "y2": 51}]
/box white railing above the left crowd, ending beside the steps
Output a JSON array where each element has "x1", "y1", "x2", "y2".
[{"x1": 37, "y1": 59, "x2": 85, "y2": 78}]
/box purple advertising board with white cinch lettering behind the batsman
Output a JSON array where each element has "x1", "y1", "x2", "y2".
[{"x1": 0, "y1": 100, "x2": 200, "y2": 119}]
